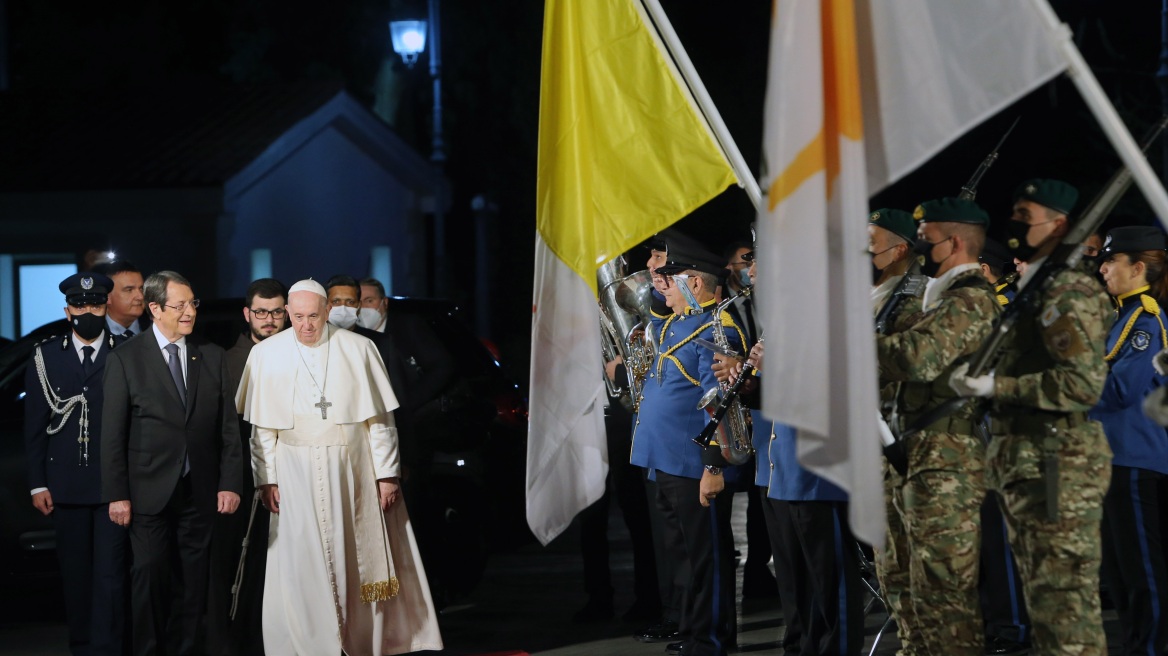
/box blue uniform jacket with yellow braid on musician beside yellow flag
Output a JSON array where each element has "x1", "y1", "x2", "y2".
[{"x1": 630, "y1": 301, "x2": 745, "y2": 483}]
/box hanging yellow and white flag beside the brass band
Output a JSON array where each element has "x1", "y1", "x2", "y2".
[{"x1": 527, "y1": 0, "x2": 735, "y2": 544}]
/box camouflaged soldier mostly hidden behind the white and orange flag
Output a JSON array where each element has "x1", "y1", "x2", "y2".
[{"x1": 868, "y1": 208, "x2": 920, "y2": 655}]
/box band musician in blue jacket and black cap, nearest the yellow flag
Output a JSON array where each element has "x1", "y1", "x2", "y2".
[{"x1": 631, "y1": 235, "x2": 745, "y2": 656}]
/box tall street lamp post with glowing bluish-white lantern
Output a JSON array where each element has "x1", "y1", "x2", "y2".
[{"x1": 389, "y1": 0, "x2": 446, "y2": 296}]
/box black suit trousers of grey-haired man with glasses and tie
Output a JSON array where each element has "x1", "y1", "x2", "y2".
[{"x1": 130, "y1": 476, "x2": 211, "y2": 656}]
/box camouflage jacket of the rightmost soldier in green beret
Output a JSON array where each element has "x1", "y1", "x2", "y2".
[{"x1": 994, "y1": 262, "x2": 1113, "y2": 414}]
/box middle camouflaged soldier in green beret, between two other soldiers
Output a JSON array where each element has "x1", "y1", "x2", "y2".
[{"x1": 876, "y1": 198, "x2": 1001, "y2": 656}]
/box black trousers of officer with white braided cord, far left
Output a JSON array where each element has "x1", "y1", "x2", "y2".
[{"x1": 53, "y1": 503, "x2": 130, "y2": 656}]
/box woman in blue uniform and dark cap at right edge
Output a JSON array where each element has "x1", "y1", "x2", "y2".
[{"x1": 1091, "y1": 226, "x2": 1168, "y2": 654}]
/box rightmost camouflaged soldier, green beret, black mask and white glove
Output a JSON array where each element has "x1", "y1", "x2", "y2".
[{"x1": 951, "y1": 180, "x2": 1112, "y2": 656}]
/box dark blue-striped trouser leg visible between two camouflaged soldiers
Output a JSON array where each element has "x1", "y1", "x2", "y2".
[{"x1": 978, "y1": 490, "x2": 1030, "y2": 642}]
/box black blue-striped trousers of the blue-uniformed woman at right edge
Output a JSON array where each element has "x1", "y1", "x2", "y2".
[{"x1": 1103, "y1": 465, "x2": 1168, "y2": 655}]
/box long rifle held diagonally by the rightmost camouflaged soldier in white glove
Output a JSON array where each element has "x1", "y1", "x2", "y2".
[{"x1": 902, "y1": 114, "x2": 1168, "y2": 439}]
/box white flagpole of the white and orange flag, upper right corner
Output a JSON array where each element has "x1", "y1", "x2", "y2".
[{"x1": 1031, "y1": 0, "x2": 1168, "y2": 224}]
